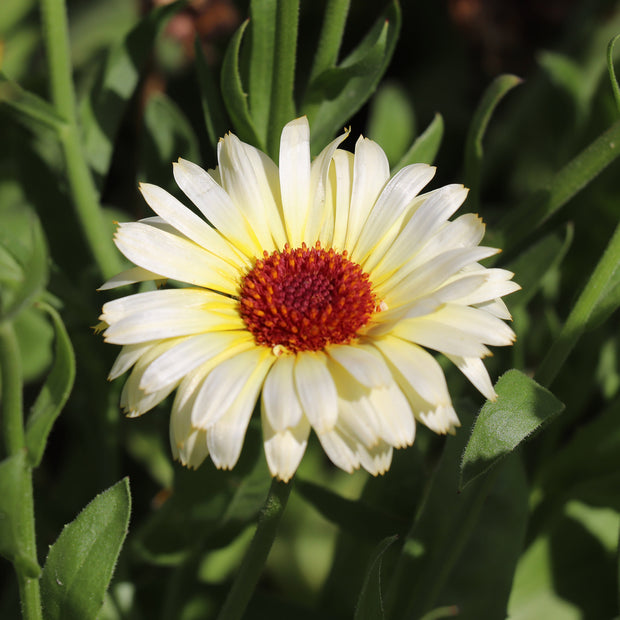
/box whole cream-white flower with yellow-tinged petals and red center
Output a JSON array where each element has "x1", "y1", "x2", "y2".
[{"x1": 100, "y1": 118, "x2": 519, "y2": 481}]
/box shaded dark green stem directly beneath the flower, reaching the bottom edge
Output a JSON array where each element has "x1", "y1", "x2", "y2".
[{"x1": 218, "y1": 480, "x2": 293, "y2": 620}]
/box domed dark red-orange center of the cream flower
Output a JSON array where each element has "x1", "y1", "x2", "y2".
[{"x1": 240, "y1": 242, "x2": 375, "y2": 352}]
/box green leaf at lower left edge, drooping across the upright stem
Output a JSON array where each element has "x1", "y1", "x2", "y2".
[{"x1": 0, "y1": 450, "x2": 41, "y2": 578}]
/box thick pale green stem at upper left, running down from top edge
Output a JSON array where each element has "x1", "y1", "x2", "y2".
[{"x1": 41, "y1": 0, "x2": 121, "y2": 278}]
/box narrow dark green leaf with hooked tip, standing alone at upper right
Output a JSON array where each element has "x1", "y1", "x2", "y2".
[{"x1": 464, "y1": 75, "x2": 522, "y2": 211}]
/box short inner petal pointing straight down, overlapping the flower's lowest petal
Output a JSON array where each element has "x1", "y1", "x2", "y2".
[{"x1": 262, "y1": 355, "x2": 303, "y2": 432}]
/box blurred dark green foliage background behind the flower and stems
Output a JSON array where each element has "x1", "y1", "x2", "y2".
[{"x1": 0, "y1": 0, "x2": 620, "y2": 620}]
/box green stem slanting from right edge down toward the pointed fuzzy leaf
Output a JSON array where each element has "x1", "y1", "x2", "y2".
[{"x1": 536, "y1": 224, "x2": 620, "y2": 387}]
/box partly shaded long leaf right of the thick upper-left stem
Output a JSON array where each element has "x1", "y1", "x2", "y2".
[{"x1": 79, "y1": 2, "x2": 182, "y2": 188}]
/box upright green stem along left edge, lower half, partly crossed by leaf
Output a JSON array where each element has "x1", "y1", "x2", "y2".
[{"x1": 0, "y1": 323, "x2": 42, "y2": 620}]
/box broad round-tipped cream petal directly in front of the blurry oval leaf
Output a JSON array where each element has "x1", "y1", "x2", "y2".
[{"x1": 344, "y1": 136, "x2": 390, "y2": 253}]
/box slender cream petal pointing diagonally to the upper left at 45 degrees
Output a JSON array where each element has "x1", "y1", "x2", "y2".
[{"x1": 172, "y1": 158, "x2": 260, "y2": 256}]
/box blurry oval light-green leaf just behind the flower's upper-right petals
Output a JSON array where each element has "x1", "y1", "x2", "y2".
[{"x1": 366, "y1": 83, "x2": 415, "y2": 166}]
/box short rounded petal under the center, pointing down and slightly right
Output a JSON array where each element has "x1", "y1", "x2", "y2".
[{"x1": 293, "y1": 351, "x2": 338, "y2": 433}]
